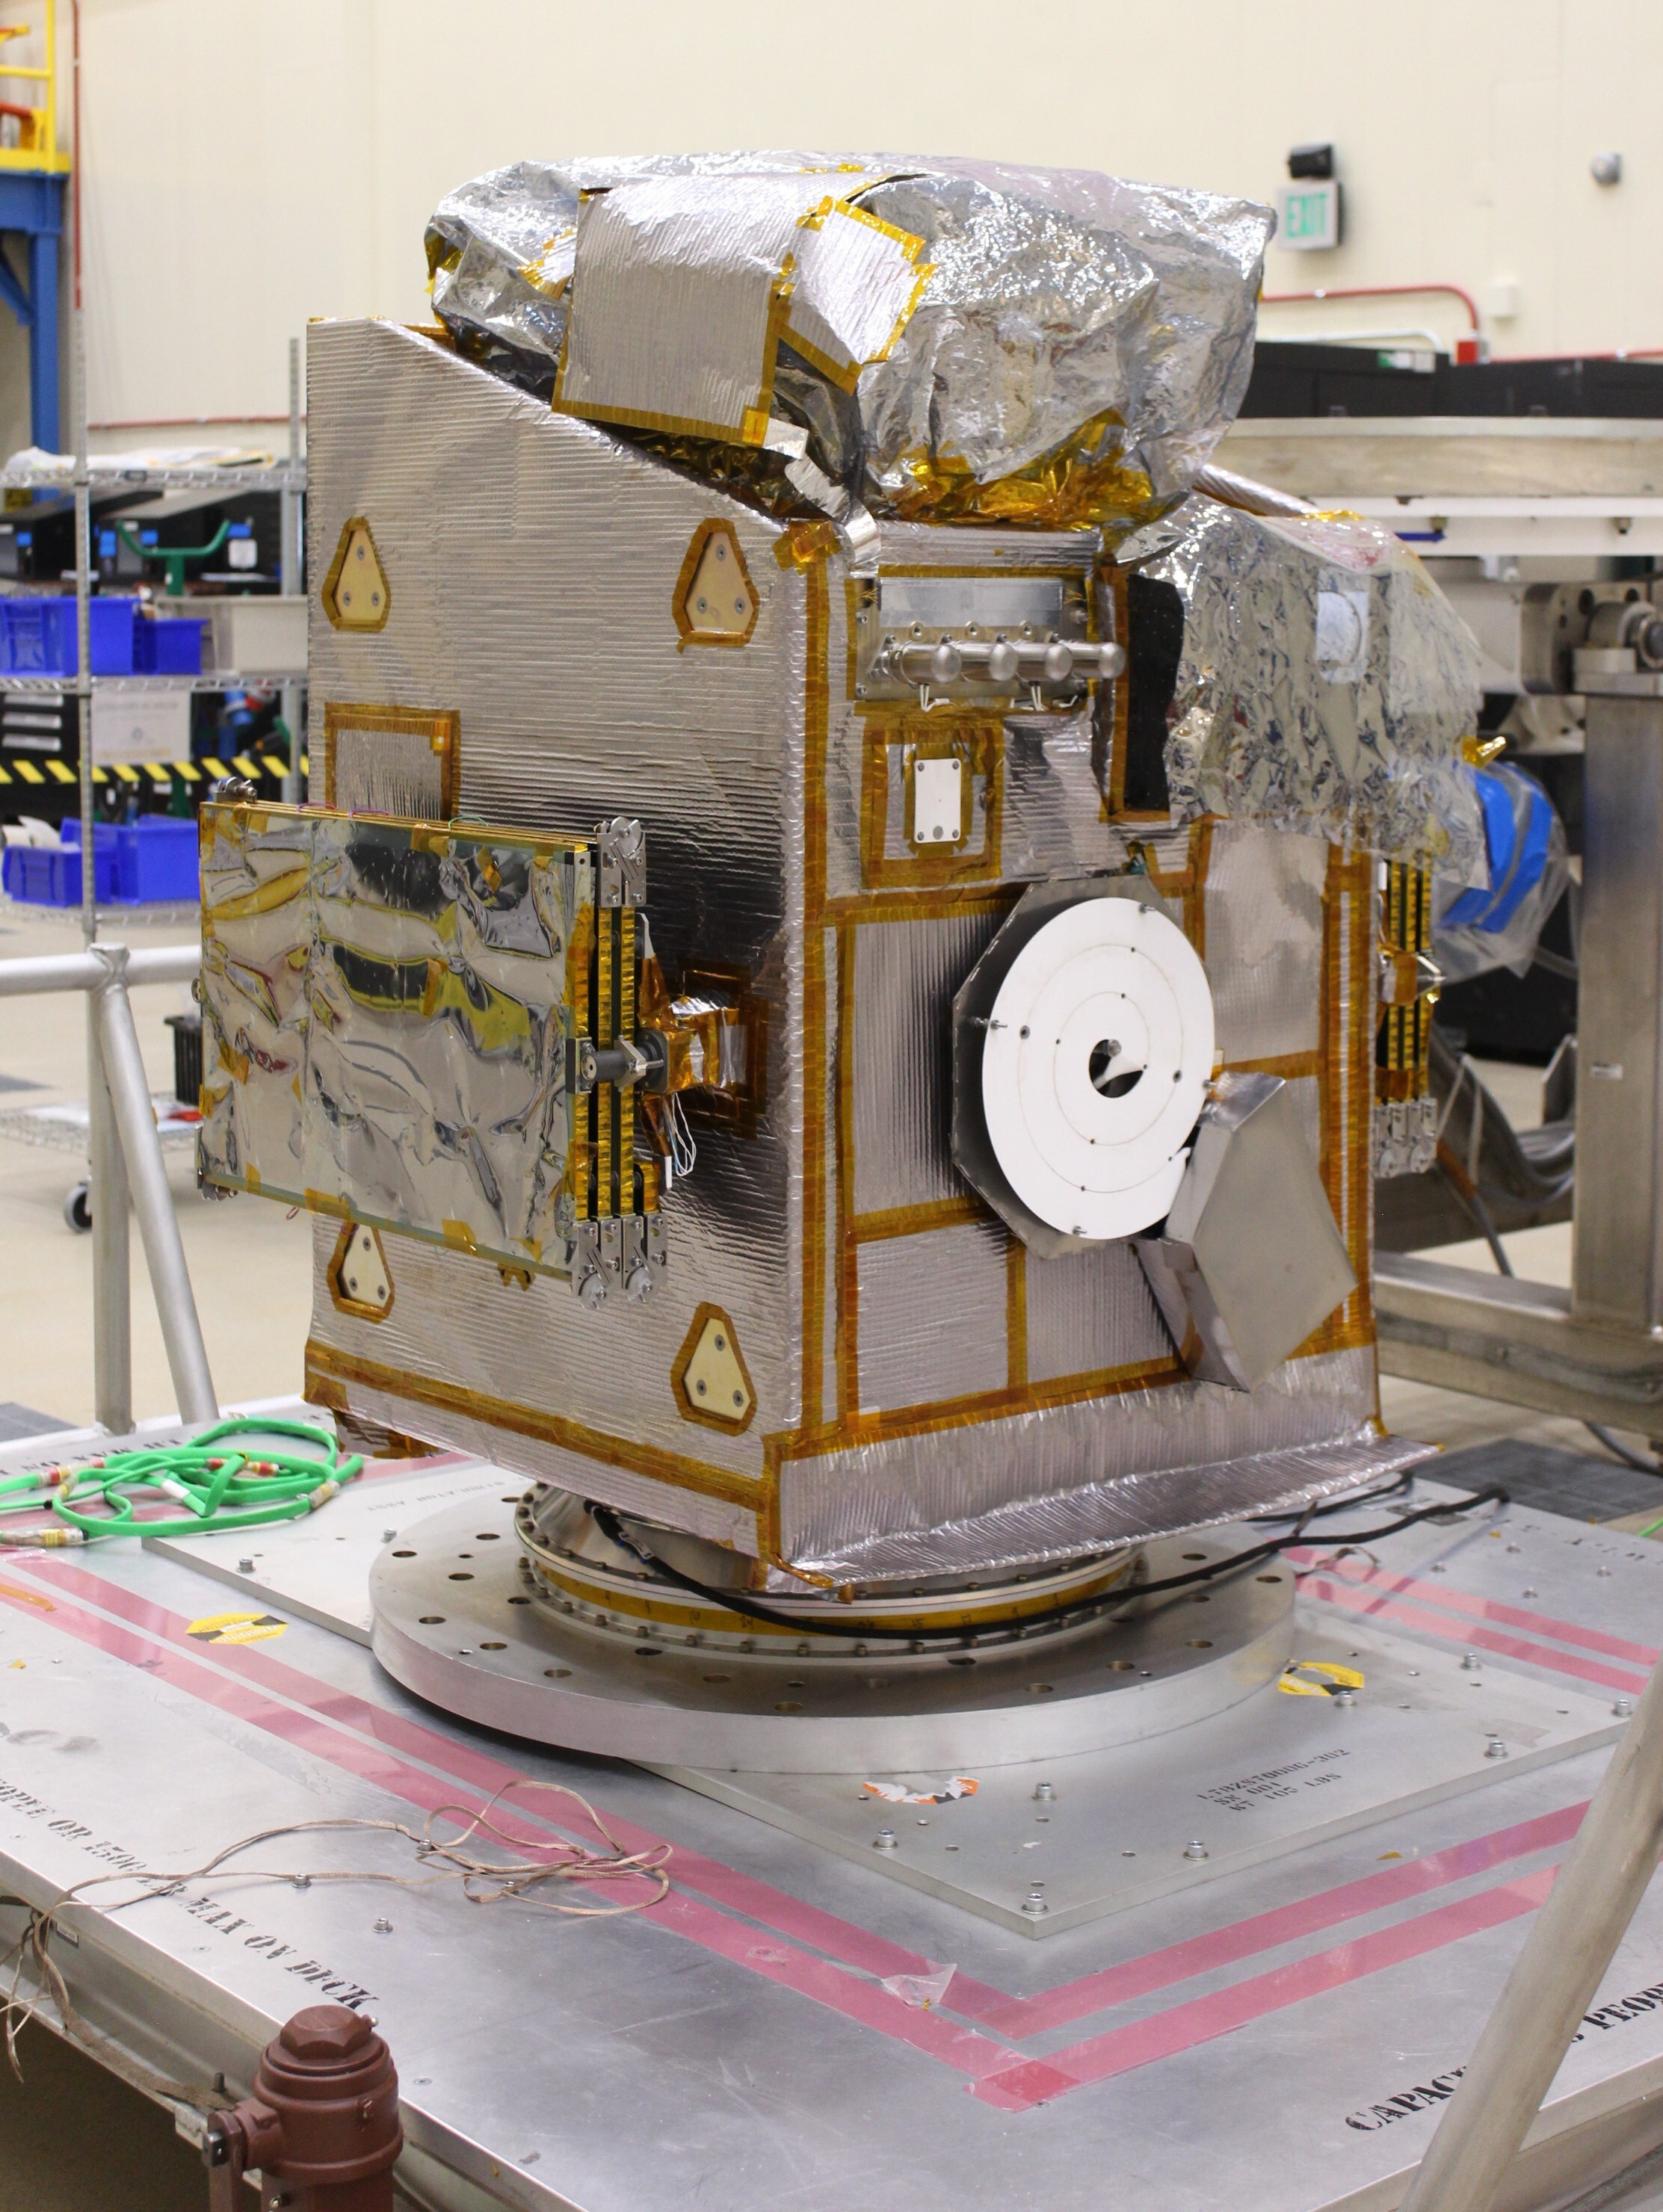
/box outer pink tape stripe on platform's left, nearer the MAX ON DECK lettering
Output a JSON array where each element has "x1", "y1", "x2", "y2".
[{"x1": 0, "y1": 1584, "x2": 1019, "y2": 2079}]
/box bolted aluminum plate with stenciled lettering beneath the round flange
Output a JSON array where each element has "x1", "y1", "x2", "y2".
[{"x1": 659, "y1": 1606, "x2": 1621, "y2": 1936}]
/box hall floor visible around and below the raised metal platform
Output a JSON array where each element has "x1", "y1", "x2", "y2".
[{"x1": 0, "y1": 907, "x2": 1659, "y2": 2212}]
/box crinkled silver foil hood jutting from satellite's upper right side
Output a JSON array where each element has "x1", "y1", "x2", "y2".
[{"x1": 1123, "y1": 498, "x2": 1484, "y2": 880}]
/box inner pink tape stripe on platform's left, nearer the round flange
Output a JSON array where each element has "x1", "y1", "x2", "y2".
[{"x1": 13, "y1": 1553, "x2": 955, "y2": 2000}]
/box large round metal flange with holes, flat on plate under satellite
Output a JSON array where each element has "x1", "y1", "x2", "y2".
[{"x1": 369, "y1": 1502, "x2": 1294, "y2": 1774}]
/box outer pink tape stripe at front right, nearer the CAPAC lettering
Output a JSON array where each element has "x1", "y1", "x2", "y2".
[{"x1": 975, "y1": 1867, "x2": 1559, "y2": 2113}]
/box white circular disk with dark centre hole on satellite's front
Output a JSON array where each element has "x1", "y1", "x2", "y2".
[{"x1": 982, "y1": 898, "x2": 1212, "y2": 1239}]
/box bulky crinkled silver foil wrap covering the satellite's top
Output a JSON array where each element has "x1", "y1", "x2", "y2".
[{"x1": 427, "y1": 152, "x2": 1271, "y2": 531}]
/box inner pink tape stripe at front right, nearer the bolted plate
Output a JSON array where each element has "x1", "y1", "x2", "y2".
[{"x1": 951, "y1": 1802, "x2": 1588, "y2": 2037}]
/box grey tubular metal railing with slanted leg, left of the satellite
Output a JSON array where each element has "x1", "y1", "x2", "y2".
[{"x1": 0, "y1": 945, "x2": 219, "y2": 1433}]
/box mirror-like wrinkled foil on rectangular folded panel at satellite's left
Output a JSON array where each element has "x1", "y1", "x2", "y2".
[{"x1": 199, "y1": 807, "x2": 593, "y2": 1267}]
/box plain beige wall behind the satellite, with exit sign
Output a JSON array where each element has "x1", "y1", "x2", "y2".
[{"x1": 22, "y1": 0, "x2": 1663, "y2": 440}]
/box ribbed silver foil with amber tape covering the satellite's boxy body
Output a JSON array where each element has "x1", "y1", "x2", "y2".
[{"x1": 307, "y1": 323, "x2": 1395, "y2": 1573}]
